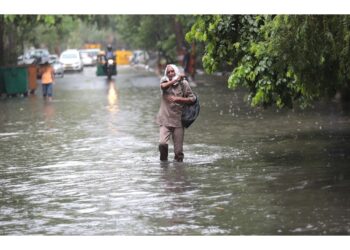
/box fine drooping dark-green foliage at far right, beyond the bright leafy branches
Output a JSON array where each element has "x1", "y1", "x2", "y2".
[{"x1": 268, "y1": 16, "x2": 350, "y2": 104}]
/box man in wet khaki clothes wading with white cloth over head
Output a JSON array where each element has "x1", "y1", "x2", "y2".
[{"x1": 156, "y1": 64, "x2": 196, "y2": 162}]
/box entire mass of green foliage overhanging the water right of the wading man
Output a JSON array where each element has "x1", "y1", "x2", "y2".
[{"x1": 186, "y1": 15, "x2": 350, "y2": 107}]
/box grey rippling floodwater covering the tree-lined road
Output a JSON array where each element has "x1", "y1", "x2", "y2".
[{"x1": 0, "y1": 67, "x2": 350, "y2": 235}]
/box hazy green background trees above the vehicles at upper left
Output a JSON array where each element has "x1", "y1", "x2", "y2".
[{"x1": 0, "y1": 15, "x2": 195, "y2": 66}]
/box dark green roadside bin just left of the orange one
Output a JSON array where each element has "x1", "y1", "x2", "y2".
[{"x1": 3, "y1": 67, "x2": 28, "y2": 95}]
